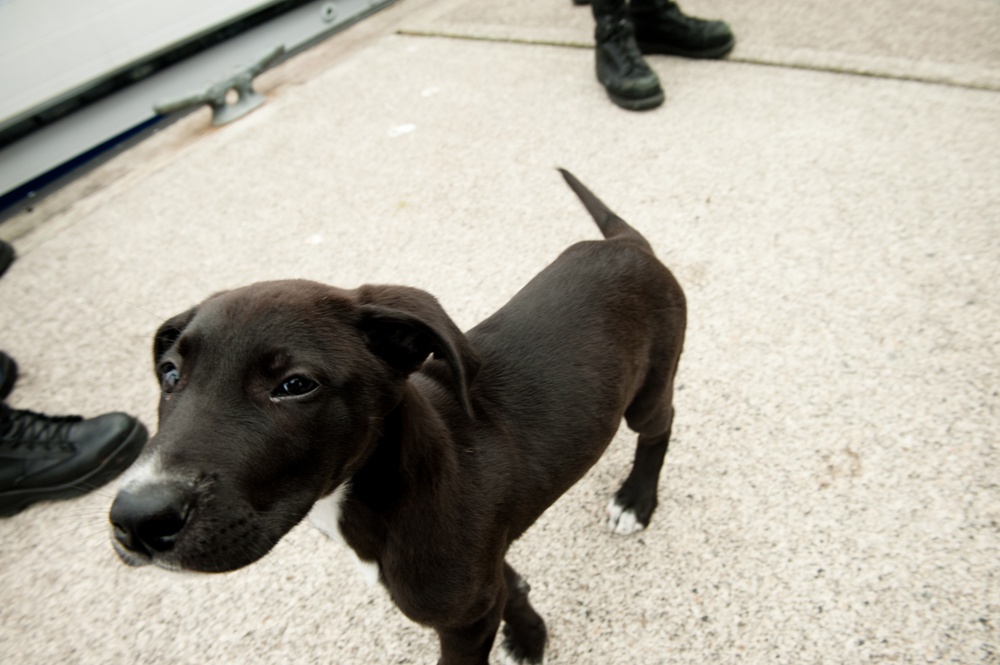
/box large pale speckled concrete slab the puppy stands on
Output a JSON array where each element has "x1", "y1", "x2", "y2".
[{"x1": 0, "y1": 0, "x2": 1000, "y2": 665}]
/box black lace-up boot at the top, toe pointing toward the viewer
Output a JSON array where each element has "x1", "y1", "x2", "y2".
[{"x1": 594, "y1": 10, "x2": 663, "y2": 111}]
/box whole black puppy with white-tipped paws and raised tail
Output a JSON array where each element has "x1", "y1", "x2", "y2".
[{"x1": 110, "y1": 171, "x2": 686, "y2": 665}]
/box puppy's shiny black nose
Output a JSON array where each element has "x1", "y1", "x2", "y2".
[{"x1": 110, "y1": 483, "x2": 191, "y2": 556}]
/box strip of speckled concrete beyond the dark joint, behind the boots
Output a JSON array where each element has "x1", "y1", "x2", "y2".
[{"x1": 402, "y1": 0, "x2": 1000, "y2": 90}]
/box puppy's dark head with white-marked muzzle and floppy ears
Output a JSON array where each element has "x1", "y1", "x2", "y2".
[{"x1": 110, "y1": 281, "x2": 477, "y2": 572}]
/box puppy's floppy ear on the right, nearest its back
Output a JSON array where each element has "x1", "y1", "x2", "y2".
[{"x1": 358, "y1": 286, "x2": 479, "y2": 416}]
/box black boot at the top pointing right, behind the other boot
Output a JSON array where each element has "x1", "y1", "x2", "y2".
[{"x1": 628, "y1": 0, "x2": 736, "y2": 58}]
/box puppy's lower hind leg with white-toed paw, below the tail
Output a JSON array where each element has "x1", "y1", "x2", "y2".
[{"x1": 608, "y1": 370, "x2": 674, "y2": 535}]
